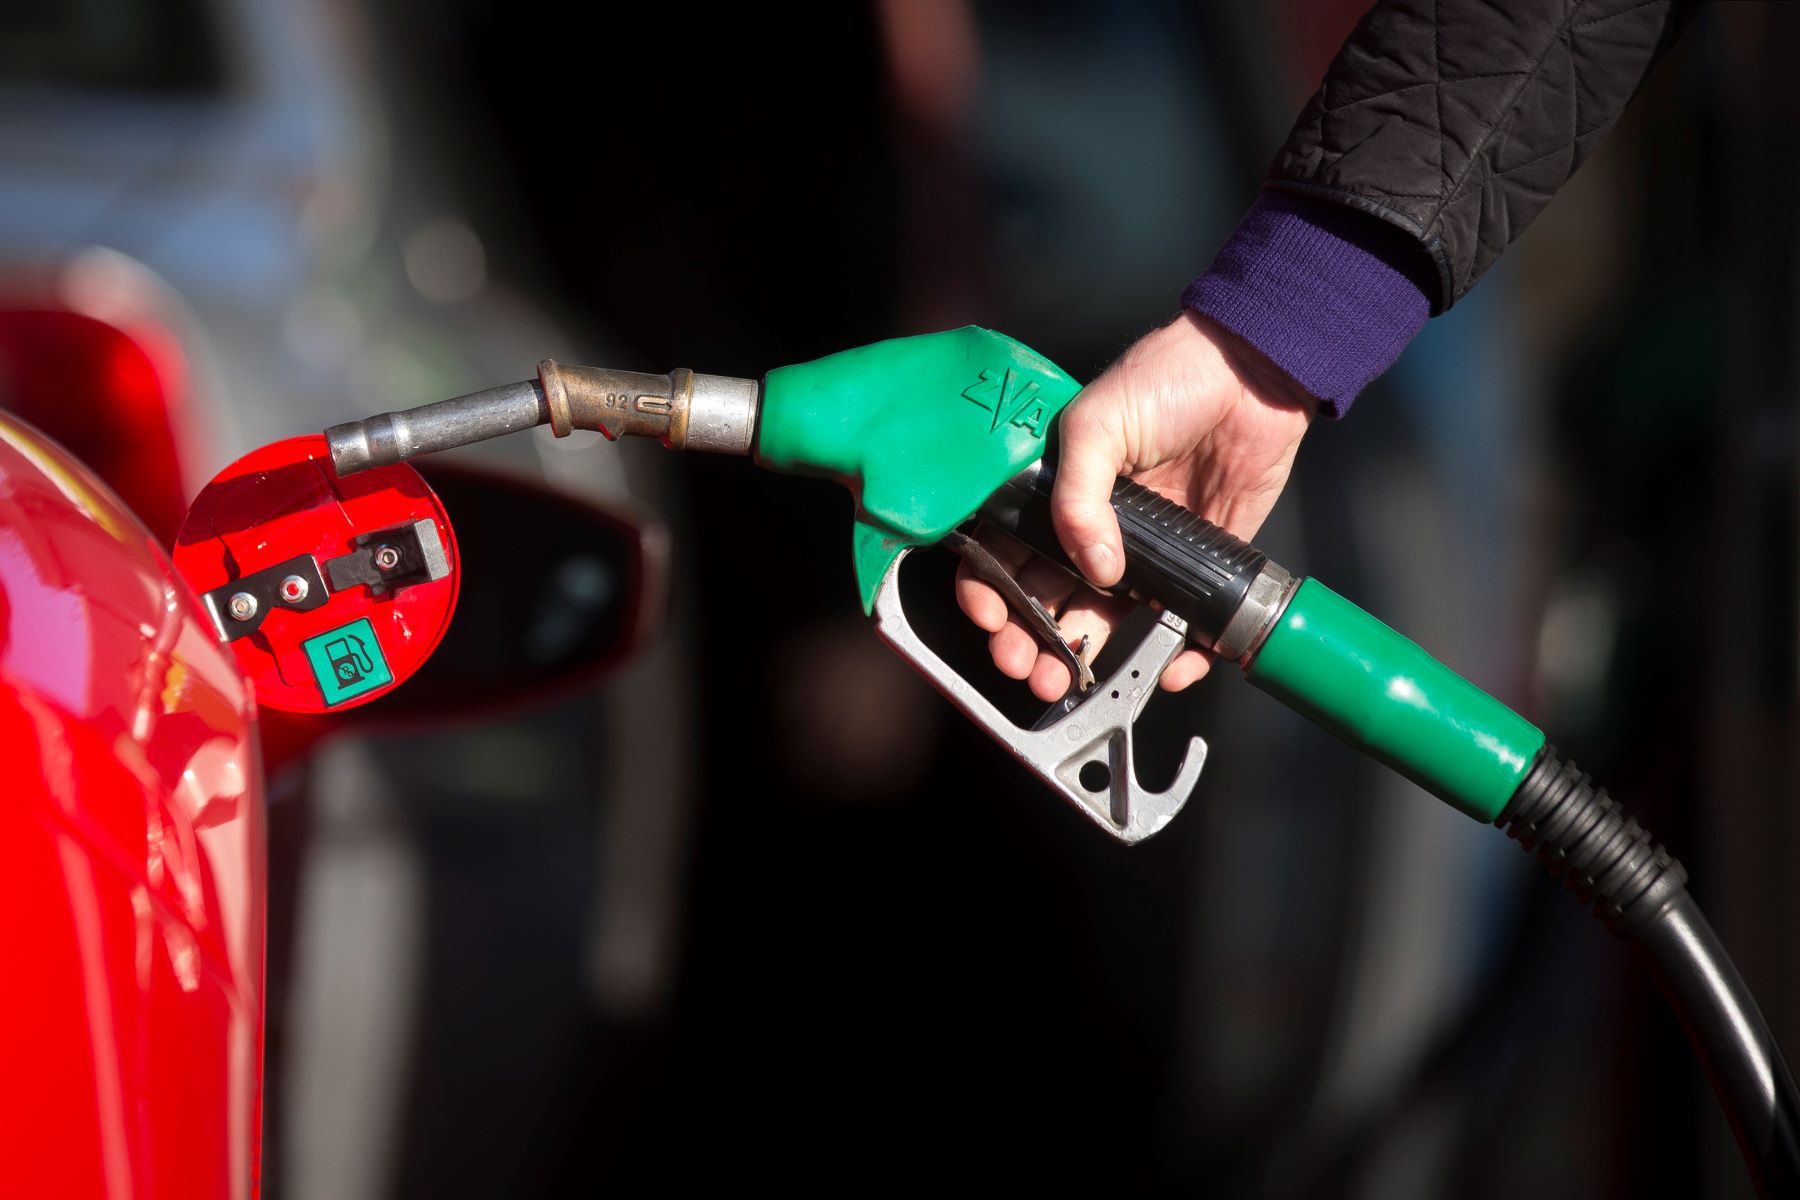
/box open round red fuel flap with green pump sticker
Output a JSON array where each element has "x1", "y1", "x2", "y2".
[{"x1": 175, "y1": 434, "x2": 459, "y2": 712}]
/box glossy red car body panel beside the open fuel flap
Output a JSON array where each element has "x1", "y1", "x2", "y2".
[{"x1": 0, "y1": 412, "x2": 266, "y2": 1198}]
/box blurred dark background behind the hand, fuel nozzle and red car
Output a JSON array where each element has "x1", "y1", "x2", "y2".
[{"x1": 0, "y1": 0, "x2": 1800, "y2": 1200}]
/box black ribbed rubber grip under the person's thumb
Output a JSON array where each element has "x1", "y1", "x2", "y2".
[{"x1": 981, "y1": 462, "x2": 1269, "y2": 646}]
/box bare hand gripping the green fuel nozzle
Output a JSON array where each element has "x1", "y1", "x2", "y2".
[{"x1": 956, "y1": 311, "x2": 1318, "y2": 700}]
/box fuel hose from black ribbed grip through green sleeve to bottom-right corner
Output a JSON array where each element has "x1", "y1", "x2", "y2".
[{"x1": 981, "y1": 464, "x2": 1800, "y2": 1196}]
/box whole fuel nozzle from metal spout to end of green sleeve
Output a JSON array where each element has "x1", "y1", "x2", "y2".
[{"x1": 326, "y1": 326, "x2": 1544, "y2": 840}]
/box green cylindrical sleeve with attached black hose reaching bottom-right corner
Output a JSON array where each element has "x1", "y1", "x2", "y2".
[{"x1": 1246, "y1": 579, "x2": 1800, "y2": 1196}]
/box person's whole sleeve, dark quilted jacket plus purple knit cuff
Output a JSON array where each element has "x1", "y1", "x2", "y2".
[{"x1": 1183, "y1": 0, "x2": 1694, "y2": 416}]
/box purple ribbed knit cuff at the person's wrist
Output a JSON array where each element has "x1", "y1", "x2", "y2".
[{"x1": 1181, "y1": 191, "x2": 1435, "y2": 417}]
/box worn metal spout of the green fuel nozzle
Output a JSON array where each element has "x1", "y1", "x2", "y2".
[{"x1": 326, "y1": 358, "x2": 760, "y2": 475}]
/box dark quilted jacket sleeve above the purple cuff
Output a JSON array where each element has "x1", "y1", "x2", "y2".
[{"x1": 1267, "y1": 0, "x2": 1696, "y2": 311}]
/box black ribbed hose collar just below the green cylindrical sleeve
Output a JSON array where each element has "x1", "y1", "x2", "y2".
[{"x1": 1494, "y1": 745, "x2": 1687, "y2": 937}]
